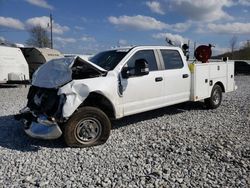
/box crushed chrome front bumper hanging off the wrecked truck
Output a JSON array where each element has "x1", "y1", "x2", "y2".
[{"x1": 15, "y1": 108, "x2": 62, "y2": 140}]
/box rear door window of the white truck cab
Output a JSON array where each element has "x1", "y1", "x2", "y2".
[{"x1": 161, "y1": 50, "x2": 183, "y2": 69}]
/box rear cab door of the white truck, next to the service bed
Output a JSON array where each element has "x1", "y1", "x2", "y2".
[{"x1": 159, "y1": 49, "x2": 191, "y2": 105}]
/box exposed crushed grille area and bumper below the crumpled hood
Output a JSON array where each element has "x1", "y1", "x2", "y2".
[{"x1": 16, "y1": 86, "x2": 66, "y2": 139}]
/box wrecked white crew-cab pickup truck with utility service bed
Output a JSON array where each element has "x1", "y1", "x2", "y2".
[{"x1": 16, "y1": 46, "x2": 236, "y2": 147}]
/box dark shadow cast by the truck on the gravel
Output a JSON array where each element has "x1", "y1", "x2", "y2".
[{"x1": 0, "y1": 102, "x2": 204, "y2": 152}]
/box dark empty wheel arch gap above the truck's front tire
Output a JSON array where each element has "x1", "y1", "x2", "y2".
[{"x1": 79, "y1": 92, "x2": 116, "y2": 119}]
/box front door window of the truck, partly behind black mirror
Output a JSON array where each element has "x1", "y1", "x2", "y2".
[{"x1": 127, "y1": 50, "x2": 158, "y2": 71}]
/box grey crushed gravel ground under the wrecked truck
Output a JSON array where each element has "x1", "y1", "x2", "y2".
[{"x1": 0, "y1": 76, "x2": 250, "y2": 188}]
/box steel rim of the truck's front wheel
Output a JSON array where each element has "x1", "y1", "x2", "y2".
[{"x1": 75, "y1": 118, "x2": 102, "y2": 144}]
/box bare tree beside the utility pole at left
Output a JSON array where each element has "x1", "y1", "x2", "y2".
[{"x1": 26, "y1": 26, "x2": 50, "y2": 48}]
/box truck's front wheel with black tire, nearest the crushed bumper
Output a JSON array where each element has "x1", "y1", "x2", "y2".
[{"x1": 64, "y1": 107, "x2": 111, "y2": 147}]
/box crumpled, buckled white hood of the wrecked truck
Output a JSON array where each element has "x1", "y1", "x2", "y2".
[{"x1": 32, "y1": 56, "x2": 107, "y2": 88}]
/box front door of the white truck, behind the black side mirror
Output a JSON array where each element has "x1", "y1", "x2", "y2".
[{"x1": 121, "y1": 49, "x2": 164, "y2": 116}]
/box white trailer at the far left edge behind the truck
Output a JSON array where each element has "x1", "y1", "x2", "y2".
[{"x1": 0, "y1": 45, "x2": 29, "y2": 84}]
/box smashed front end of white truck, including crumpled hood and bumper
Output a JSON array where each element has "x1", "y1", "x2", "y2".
[{"x1": 15, "y1": 57, "x2": 105, "y2": 139}]
